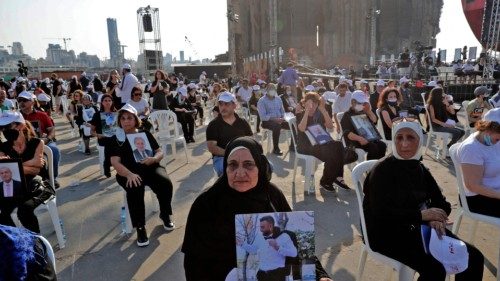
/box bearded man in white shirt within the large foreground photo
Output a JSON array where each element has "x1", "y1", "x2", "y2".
[{"x1": 236, "y1": 216, "x2": 297, "y2": 281}]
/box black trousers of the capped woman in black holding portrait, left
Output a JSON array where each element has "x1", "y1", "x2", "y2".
[{"x1": 116, "y1": 166, "x2": 173, "y2": 227}]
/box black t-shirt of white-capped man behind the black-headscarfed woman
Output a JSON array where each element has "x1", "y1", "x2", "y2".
[{"x1": 206, "y1": 113, "x2": 253, "y2": 153}]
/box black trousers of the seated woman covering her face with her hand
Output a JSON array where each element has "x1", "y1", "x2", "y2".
[{"x1": 298, "y1": 141, "x2": 344, "y2": 184}]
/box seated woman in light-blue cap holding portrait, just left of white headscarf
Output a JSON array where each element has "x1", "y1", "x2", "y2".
[{"x1": 340, "y1": 90, "x2": 387, "y2": 160}]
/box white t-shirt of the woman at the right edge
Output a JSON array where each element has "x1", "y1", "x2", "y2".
[{"x1": 458, "y1": 132, "x2": 500, "y2": 196}]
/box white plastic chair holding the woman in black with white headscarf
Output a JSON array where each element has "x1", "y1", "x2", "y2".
[{"x1": 351, "y1": 160, "x2": 415, "y2": 281}]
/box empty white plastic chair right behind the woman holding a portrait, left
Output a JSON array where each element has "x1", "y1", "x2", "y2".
[{"x1": 149, "y1": 110, "x2": 189, "y2": 163}]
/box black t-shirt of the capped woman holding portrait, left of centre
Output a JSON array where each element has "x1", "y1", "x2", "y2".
[{"x1": 107, "y1": 131, "x2": 160, "y2": 177}]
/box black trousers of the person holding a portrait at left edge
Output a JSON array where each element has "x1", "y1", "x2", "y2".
[{"x1": 0, "y1": 195, "x2": 43, "y2": 233}]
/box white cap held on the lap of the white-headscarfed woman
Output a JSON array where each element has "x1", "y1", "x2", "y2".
[{"x1": 429, "y1": 229, "x2": 469, "y2": 274}]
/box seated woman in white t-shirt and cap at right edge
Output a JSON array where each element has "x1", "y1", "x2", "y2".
[{"x1": 458, "y1": 108, "x2": 500, "y2": 218}]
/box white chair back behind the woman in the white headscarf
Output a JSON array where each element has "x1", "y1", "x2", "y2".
[{"x1": 351, "y1": 160, "x2": 378, "y2": 250}]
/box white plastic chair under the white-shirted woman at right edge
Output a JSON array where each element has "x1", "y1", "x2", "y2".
[{"x1": 450, "y1": 143, "x2": 500, "y2": 281}]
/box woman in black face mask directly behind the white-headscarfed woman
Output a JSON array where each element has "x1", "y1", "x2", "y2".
[{"x1": 377, "y1": 87, "x2": 402, "y2": 140}]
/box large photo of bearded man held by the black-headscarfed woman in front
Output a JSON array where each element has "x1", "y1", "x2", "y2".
[{"x1": 235, "y1": 211, "x2": 316, "y2": 281}]
